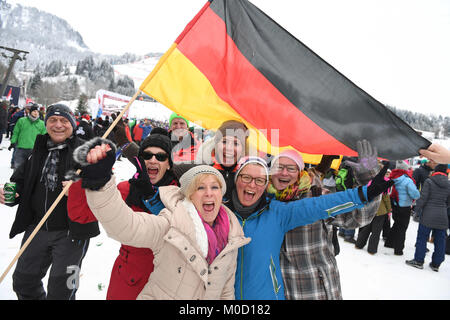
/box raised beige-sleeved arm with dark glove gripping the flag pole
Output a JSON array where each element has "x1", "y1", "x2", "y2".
[{"x1": 74, "y1": 138, "x2": 169, "y2": 249}]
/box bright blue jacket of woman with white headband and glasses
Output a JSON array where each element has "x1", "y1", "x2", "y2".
[{"x1": 234, "y1": 187, "x2": 367, "y2": 300}]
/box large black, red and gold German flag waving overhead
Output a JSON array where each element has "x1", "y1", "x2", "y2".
[{"x1": 140, "y1": 0, "x2": 430, "y2": 160}]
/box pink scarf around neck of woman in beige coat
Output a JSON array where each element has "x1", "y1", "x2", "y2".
[{"x1": 199, "y1": 206, "x2": 230, "y2": 264}]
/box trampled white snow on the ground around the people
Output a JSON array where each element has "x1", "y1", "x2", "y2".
[{"x1": 0, "y1": 139, "x2": 450, "y2": 300}]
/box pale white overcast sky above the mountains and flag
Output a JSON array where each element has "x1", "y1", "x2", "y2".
[{"x1": 8, "y1": 0, "x2": 450, "y2": 116}]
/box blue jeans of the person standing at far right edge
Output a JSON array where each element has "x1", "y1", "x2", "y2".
[{"x1": 414, "y1": 223, "x2": 447, "y2": 267}]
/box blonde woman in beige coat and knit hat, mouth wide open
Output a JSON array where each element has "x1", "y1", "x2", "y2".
[{"x1": 82, "y1": 140, "x2": 250, "y2": 300}]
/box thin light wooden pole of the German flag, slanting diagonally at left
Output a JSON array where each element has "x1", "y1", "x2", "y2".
[{"x1": 0, "y1": 90, "x2": 141, "y2": 283}]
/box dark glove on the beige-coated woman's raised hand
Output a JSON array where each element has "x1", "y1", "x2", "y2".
[{"x1": 73, "y1": 137, "x2": 116, "y2": 190}]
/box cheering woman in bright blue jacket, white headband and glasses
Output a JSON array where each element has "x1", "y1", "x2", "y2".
[{"x1": 227, "y1": 157, "x2": 393, "y2": 300}]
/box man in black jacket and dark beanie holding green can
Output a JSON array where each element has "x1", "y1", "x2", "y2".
[{"x1": 0, "y1": 104, "x2": 100, "y2": 300}]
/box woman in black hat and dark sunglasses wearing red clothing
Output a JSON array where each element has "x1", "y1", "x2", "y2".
[{"x1": 68, "y1": 131, "x2": 178, "y2": 300}]
